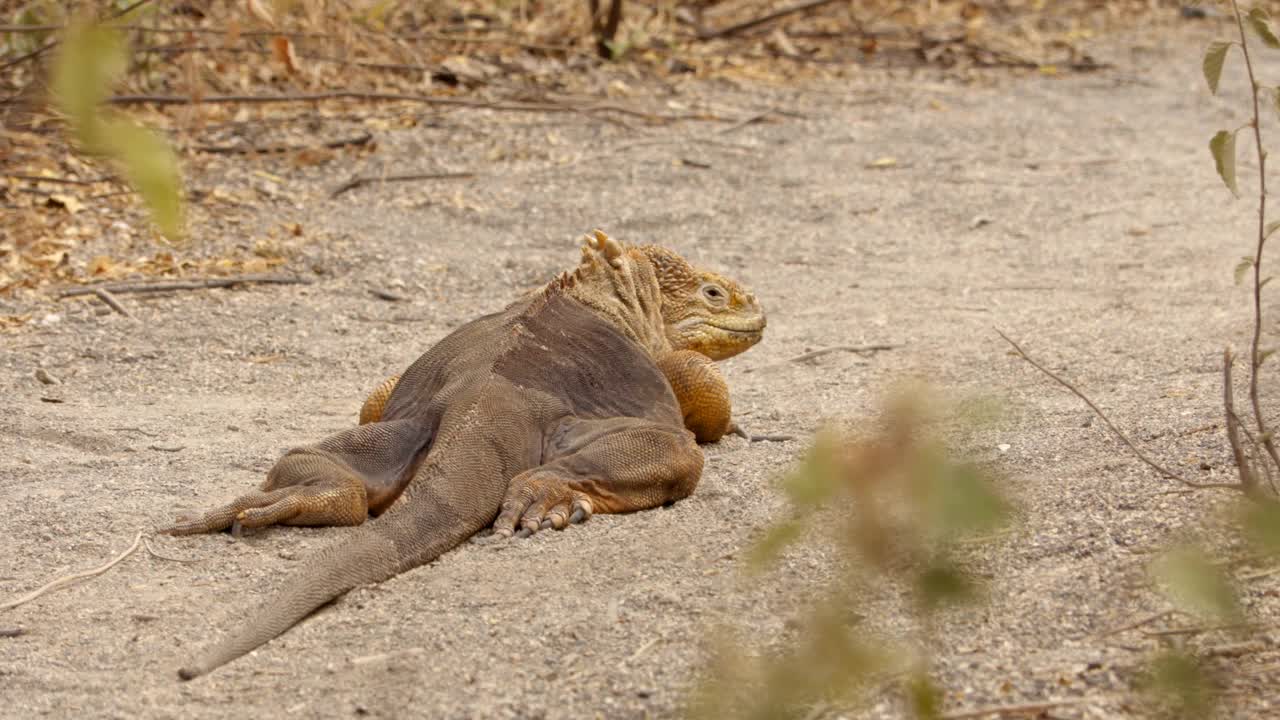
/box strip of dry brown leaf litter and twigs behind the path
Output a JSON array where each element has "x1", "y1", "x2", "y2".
[{"x1": 0, "y1": 0, "x2": 1203, "y2": 304}]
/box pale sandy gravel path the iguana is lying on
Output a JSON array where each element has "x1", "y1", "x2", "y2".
[{"x1": 0, "y1": 22, "x2": 1280, "y2": 717}]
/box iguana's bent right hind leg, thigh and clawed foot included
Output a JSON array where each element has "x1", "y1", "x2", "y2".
[{"x1": 493, "y1": 418, "x2": 703, "y2": 537}]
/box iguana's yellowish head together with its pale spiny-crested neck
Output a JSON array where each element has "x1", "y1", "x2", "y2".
[{"x1": 558, "y1": 231, "x2": 765, "y2": 360}]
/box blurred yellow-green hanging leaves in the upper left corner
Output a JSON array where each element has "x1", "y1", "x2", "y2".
[{"x1": 54, "y1": 19, "x2": 182, "y2": 238}]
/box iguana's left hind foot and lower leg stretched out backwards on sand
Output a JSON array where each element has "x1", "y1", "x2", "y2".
[{"x1": 157, "y1": 456, "x2": 369, "y2": 536}]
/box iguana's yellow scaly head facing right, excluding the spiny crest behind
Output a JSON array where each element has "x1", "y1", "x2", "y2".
[{"x1": 637, "y1": 245, "x2": 765, "y2": 360}]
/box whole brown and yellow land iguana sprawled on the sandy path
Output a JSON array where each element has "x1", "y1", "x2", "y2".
[{"x1": 163, "y1": 231, "x2": 765, "y2": 679}]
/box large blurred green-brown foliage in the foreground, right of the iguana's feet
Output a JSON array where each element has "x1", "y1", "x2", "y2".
[{"x1": 690, "y1": 393, "x2": 1009, "y2": 720}]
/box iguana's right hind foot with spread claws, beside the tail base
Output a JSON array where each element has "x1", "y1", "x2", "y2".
[{"x1": 493, "y1": 469, "x2": 593, "y2": 538}]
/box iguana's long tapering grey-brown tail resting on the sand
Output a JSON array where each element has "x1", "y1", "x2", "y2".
[{"x1": 178, "y1": 491, "x2": 498, "y2": 680}]
